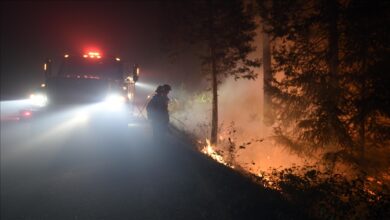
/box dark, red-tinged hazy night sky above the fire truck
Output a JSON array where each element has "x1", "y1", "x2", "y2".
[{"x1": 1, "y1": 1, "x2": 201, "y2": 99}]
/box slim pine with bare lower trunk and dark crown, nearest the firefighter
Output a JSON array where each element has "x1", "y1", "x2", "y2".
[{"x1": 163, "y1": 0, "x2": 259, "y2": 145}]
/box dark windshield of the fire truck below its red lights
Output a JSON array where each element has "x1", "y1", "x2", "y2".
[{"x1": 57, "y1": 57, "x2": 123, "y2": 80}]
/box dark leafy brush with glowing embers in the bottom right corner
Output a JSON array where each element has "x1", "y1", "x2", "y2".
[{"x1": 254, "y1": 166, "x2": 390, "y2": 219}]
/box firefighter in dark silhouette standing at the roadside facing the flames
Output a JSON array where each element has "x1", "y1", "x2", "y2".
[{"x1": 146, "y1": 84, "x2": 171, "y2": 139}]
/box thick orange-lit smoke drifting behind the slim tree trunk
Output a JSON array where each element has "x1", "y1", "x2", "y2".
[{"x1": 171, "y1": 77, "x2": 303, "y2": 173}]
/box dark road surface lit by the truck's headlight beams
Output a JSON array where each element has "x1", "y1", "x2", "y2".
[{"x1": 1, "y1": 109, "x2": 302, "y2": 220}]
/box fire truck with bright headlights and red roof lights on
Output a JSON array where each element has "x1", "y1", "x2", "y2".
[{"x1": 21, "y1": 51, "x2": 140, "y2": 119}]
